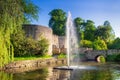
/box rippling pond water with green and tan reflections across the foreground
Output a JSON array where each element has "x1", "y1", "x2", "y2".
[{"x1": 0, "y1": 62, "x2": 120, "y2": 80}]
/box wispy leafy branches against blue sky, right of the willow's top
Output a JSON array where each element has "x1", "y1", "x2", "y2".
[{"x1": 20, "y1": 0, "x2": 39, "y2": 23}]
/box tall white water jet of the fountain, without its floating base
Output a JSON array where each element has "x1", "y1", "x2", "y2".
[{"x1": 66, "y1": 12, "x2": 80, "y2": 67}]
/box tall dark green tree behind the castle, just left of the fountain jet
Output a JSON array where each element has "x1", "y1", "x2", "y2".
[{"x1": 49, "y1": 9, "x2": 66, "y2": 36}]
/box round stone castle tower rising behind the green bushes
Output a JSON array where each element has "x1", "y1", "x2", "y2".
[{"x1": 23, "y1": 24, "x2": 53, "y2": 55}]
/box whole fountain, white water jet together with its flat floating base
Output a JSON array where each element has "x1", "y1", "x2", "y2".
[{"x1": 54, "y1": 12, "x2": 96, "y2": 70}]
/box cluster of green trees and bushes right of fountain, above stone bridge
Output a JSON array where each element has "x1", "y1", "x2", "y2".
[{"x1": 74, "y1": 17, "x2": 115, "y2": 50}]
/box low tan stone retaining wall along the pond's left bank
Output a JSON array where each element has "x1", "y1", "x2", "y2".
[{"x1": 1, "y1": 58, "x2": 67, "y2": 73}]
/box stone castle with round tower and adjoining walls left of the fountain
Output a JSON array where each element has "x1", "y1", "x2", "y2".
[{"x1": 23, "y1": 24, "x2": 66, "y2": 55}]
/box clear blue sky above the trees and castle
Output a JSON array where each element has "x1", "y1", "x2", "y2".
[{"x1": 32, "y1": 0, "x2": 120, "y2": 37}]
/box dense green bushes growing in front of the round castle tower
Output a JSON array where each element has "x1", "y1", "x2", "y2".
[{"x1": 11, "y1": 31, "x2": 49, "y2": 57}]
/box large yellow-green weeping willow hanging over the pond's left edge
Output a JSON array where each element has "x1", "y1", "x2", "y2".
[{"x1": 0, "y1": 0, "x2": 37, "y2": 67}]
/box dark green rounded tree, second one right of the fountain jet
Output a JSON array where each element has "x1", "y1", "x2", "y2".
[{"x1": 84, "y1": 20, "x2": 96, "y2": 41}]
